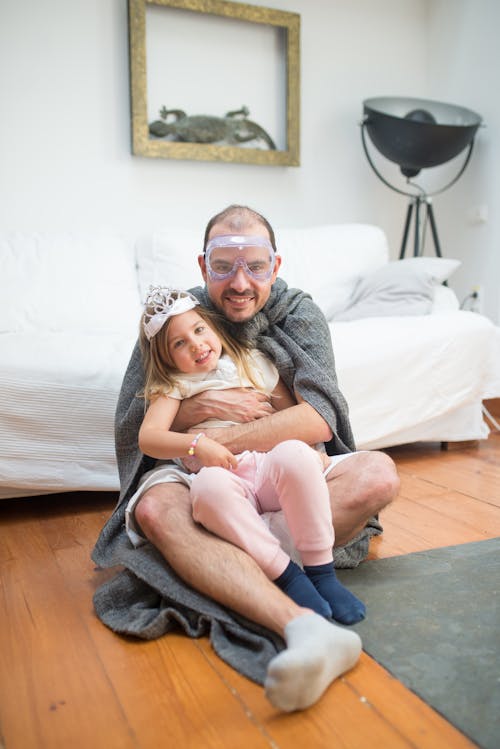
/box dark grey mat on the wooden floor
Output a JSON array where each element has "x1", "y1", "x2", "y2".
[{"x1": 338, "y1": 538, "x2": 500, "y2": 749}]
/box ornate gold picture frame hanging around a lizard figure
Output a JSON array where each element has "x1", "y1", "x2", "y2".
[{"x1": 129, "y1": 0, "x2": 300, "y2": 166}]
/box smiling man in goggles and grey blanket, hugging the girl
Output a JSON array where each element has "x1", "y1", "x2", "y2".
[{"x1": 94, "y1": 206, "x2": 398, "y2": 710}]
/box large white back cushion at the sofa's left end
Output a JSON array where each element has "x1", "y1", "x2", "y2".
[{"x1": 0, "y1": 233, "x2": 141, "y2": 333}]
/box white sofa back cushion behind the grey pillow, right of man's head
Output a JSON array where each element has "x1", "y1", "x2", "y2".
[{"x1": 276, "y1": 224, "x2": 389, "y2": 320}]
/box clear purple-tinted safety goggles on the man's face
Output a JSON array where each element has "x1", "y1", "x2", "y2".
[{"x1": 205, "y1": 234, "x2": 276, "y2": 281}]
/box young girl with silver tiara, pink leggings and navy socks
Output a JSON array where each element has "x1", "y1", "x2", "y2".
[{"x1": 133, "y1": 287, "x2": 365, "y2": 624}]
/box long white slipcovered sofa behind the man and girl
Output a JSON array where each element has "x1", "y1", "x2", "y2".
[{"x1": 0, "y1": 224, "x2": 500, "y2": 498}]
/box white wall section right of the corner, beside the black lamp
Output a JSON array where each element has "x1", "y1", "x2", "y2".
[{"x1": 428, "y1": 0, "x2": 500, "y2": 323}]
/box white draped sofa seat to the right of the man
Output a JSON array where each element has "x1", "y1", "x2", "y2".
[{"x1": 329, "y1": 311, "x2": 500, "y2": 450}]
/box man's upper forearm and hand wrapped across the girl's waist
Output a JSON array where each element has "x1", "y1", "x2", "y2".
[{"x1": 172, "y1": 388, "x2": 274, "y2": 432}]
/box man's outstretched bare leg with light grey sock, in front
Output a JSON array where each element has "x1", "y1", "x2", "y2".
[{"x1": 135, "y1": 483, "x2": 361, "y2": 712}]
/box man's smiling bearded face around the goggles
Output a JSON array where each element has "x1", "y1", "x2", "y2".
[{"x1": 198, "y1": 222, "x2": 281, "y2": 322}]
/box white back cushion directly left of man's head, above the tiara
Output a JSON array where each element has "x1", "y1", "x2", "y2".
[{"x1": 135, "y1": 229, "x2": 204, "y2": 301}]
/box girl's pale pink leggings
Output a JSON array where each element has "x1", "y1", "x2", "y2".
[{"x1": 191, "y1": 440, "x2": 334, "y2": 580}]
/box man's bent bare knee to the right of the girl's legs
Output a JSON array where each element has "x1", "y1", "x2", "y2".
[{"x1": 326, "y1": 451, "x2": 399, "y2": 546}]
